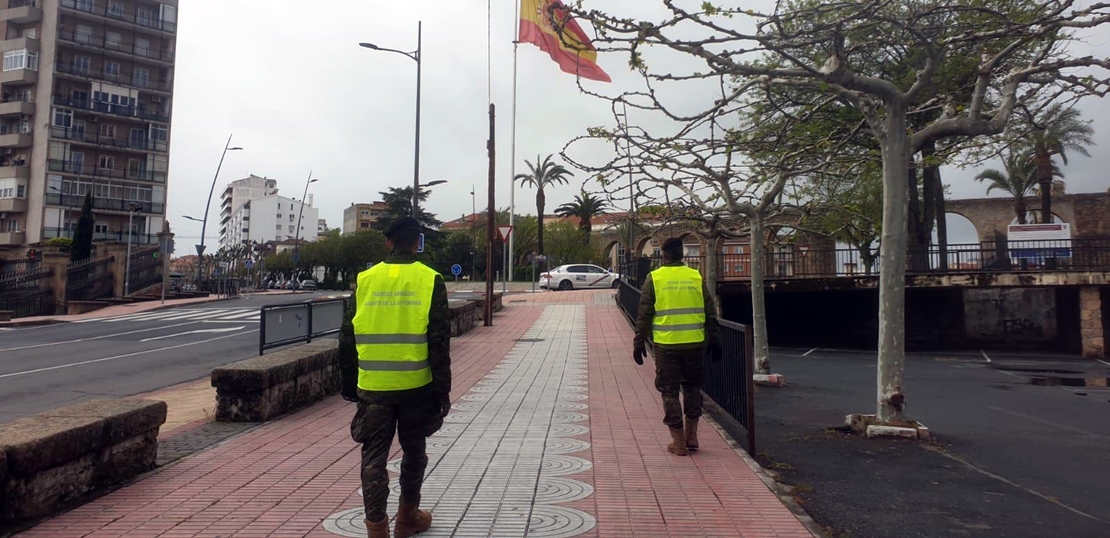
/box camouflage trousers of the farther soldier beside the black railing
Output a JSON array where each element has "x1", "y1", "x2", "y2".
[{"x1": 655, "y1": 346, "x2": 705, "y2": 428}]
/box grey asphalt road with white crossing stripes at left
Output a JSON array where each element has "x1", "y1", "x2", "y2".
[{"x1": 0, "y1": 292, "x2": 327, "y2": 423}]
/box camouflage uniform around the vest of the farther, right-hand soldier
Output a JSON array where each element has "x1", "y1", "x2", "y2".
[{"x1": 633, "y1": 262, "x2": 718, "y2": 428}]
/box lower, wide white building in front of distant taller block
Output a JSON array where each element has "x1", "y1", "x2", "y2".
[{"x1": 220, "y1": 194, "x2": 320, "y2": 246}]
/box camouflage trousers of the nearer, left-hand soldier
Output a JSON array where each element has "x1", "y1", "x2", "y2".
[{"x1": 351, "y1": 397, "x2": 437, "y2": 521}]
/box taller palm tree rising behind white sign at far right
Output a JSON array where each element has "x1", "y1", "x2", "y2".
[{"x1": 1031, "y1": 104, "x2": 1094, "y2": 222}]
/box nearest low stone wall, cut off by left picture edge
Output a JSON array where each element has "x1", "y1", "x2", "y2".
[{"x1": 0, "y1": 399, "x2": 167, "y2": 521}]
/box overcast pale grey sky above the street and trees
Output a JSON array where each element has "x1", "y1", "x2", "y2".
[{"x1": 167, "y1": 0, "x2": 1110, "y2": 249}]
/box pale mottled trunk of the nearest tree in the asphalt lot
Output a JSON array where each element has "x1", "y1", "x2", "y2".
[{"x1": 877, "y1": 110, "x2": 910, "y2": 423}]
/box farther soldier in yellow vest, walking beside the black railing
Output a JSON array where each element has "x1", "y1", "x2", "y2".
[{"x1": 633, "y1": 237, "x2": 720, "y2": 456}]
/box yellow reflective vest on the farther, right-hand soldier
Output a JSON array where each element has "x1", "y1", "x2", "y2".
[{"x1": 652, "y1": 265, "x2": 705, "y2": 345}]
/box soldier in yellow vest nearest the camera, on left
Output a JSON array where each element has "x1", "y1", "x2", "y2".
[{"x1": 339, "y1": 217, "x2": 451, "y2": 538}]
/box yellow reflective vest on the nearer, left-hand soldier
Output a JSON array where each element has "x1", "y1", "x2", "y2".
[{"x1": 354, "y1": 262, "x2": 437, "y2": 392}]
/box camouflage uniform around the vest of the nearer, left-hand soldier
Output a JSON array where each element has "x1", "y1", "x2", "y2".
[{"x1": 339, "y1": 253, "x2": 451, "y2": 521}]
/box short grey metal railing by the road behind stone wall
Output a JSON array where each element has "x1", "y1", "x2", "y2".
[{"x1": 259, "y1": 298, "x2": 347, "y2": 355}]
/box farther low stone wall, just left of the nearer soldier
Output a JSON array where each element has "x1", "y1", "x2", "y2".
[{"x1": 212, "y1": 339, "x2": 340, "y2": 423}]
